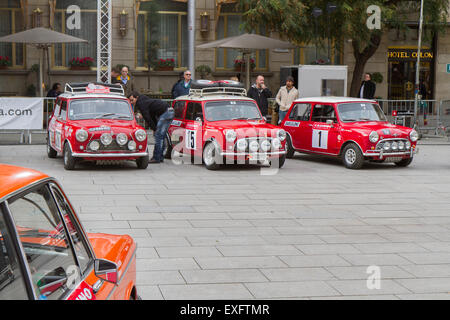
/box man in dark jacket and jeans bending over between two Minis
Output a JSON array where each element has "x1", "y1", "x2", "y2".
[{"x1": 128, "y1": 92, "x2": 175, "y2": 163}]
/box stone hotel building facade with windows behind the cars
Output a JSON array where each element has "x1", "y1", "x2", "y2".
[{"x1": 0, "y1": 0, "x2": 450, "y2": 99}]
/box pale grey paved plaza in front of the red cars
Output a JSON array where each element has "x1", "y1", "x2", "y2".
[{"x1": 0, "y1": 144, "x2": 450, "y2": 299}]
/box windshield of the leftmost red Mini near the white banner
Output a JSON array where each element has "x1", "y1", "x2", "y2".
[{"x1": 69, "y1": 99, "x2": 133, "y2": 120}]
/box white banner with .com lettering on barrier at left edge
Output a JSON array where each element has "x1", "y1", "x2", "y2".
[{"x1": 0, "y1": 98, "x2": 44, "y2": 130}]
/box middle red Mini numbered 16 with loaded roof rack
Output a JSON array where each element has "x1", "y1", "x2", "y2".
[{"x1": 166, "y1": 80, "x2": 286, "y2": 170}]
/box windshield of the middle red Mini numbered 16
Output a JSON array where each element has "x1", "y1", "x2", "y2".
[{"x1": 205, "y1": 100, "x2": 262, "y2": 121}]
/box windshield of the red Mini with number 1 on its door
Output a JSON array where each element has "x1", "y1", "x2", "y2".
[{"x1": 338, "y1": 102, "x2": 387, "y2": 122}]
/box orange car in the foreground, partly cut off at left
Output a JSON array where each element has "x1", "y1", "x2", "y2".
[{"x1": 0, "y1": 164, "x2": 139, "y2": 300}]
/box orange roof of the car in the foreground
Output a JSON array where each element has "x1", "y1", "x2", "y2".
[{"x1": 0, "y1": 164, "x2": 48, "y2": 199}]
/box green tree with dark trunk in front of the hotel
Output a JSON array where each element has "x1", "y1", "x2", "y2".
[{"x1": 239, "y1": 0, "x2": 449, "y2": 96}]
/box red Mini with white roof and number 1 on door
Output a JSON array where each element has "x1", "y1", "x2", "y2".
[{"x1": 280, "y1": 97, "x2": 419, "y2": 169}]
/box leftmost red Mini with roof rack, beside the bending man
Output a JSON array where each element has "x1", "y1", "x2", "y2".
[{"x1": 47, "y1": 83, "x2": 149, "y2": 170}]
